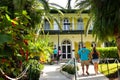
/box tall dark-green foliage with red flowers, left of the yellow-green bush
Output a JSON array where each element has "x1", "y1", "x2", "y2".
[{"x1": 0, "y1": 0, "x2": 62, "y2": 77}]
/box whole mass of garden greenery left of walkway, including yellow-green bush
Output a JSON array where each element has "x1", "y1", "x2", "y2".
[{"x1": 0, "y1": 0, "x2": 53, "y2": 80}]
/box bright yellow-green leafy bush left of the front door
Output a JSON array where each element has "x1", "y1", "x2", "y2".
[{"x1": 28, "y1": 34, "x2": 53, "y2": 63}]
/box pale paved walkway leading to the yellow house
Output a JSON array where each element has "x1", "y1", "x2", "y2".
[{"x1": 39, "y1": 63, "x2": 109, "y2": 80}]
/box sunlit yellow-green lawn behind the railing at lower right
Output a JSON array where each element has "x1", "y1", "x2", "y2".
[{"x1": 99, "y1": 63, "x2": 120, "y2": 80}]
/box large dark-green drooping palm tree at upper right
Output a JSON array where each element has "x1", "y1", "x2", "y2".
[{"x1": 76, "y1": 0, "x2": 120, "y2": 57}]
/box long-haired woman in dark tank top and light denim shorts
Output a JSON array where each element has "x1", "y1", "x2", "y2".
[{"x1": 91, "y1": 47, "x2": 100, "y2": 74}]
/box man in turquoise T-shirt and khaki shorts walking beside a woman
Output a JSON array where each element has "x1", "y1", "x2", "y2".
[{"x1": 78, "y1": 45, "x2": 90, "y2": 75}]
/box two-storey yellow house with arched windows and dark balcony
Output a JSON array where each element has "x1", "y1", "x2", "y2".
[{"x1": 44, "y1": 10, "x2": 100, "y2": 59}]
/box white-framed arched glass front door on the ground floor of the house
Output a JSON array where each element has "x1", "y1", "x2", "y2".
[{"x1": 62, "y1": 40, "x2": 72, "y2": 59}]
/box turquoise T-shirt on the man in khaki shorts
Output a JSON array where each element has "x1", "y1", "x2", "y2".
[{"x1": 78, "y1": 48, "x2": 90, "y2": 61}]
